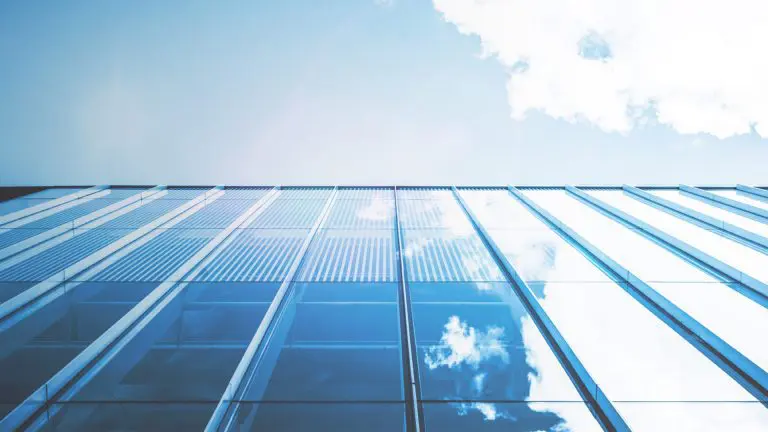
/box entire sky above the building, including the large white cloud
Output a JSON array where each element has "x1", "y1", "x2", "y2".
[{"x1": 0, "y1": 0, "x2": 768, "y2": 185}]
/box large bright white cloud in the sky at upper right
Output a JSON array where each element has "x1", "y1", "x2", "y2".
[{"x1": 434, "y1": 0, "x2": 768, "y2": 138}]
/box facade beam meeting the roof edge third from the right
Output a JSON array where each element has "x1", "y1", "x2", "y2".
[{"x1": 622, "y1": 185, "x2": 768, "y2": 253}]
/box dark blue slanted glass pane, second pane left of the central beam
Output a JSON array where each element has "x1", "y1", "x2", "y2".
[{"x1": 66, "y1": 284, "x2": 278, "y2": 409}]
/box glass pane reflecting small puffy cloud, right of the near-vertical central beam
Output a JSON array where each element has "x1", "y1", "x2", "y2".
[{"x1": 411, "y1": 283, "x2": 582, "y2": 408}]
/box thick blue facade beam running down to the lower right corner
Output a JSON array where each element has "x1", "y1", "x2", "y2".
[{"x1": 509, "y1": 187, "x2": 768, "y2": 403}]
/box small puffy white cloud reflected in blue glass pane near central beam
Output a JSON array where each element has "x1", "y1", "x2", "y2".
[{"x1": 424, "y1": 315, "x2": 509, "y2": 370}]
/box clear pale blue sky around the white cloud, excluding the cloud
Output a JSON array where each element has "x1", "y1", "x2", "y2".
[{"x1": 0, "y1": 0, "x2": 768, "y2": 185}]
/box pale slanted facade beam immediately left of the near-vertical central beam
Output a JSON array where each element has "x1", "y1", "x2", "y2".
[{"x1": 205, "y1": 187, "x2": 338, "y2": 431}]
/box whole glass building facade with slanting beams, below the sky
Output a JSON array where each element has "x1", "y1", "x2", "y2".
[{"x1": 0, "y1": 186, "x2": 768, "y2": 432}]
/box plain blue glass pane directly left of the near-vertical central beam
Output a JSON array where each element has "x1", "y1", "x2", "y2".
[{"x1": 242, "y1": 283, "x2": 404, "y2": 403}]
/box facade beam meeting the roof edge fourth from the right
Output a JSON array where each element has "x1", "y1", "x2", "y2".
[{"x1": 565, "y1": 186, "x2": 768, "y2": 306}]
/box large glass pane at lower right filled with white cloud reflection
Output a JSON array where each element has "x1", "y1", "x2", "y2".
[{"x1": 539, "y1": 282, "x2": 755, "y2": 404}]
